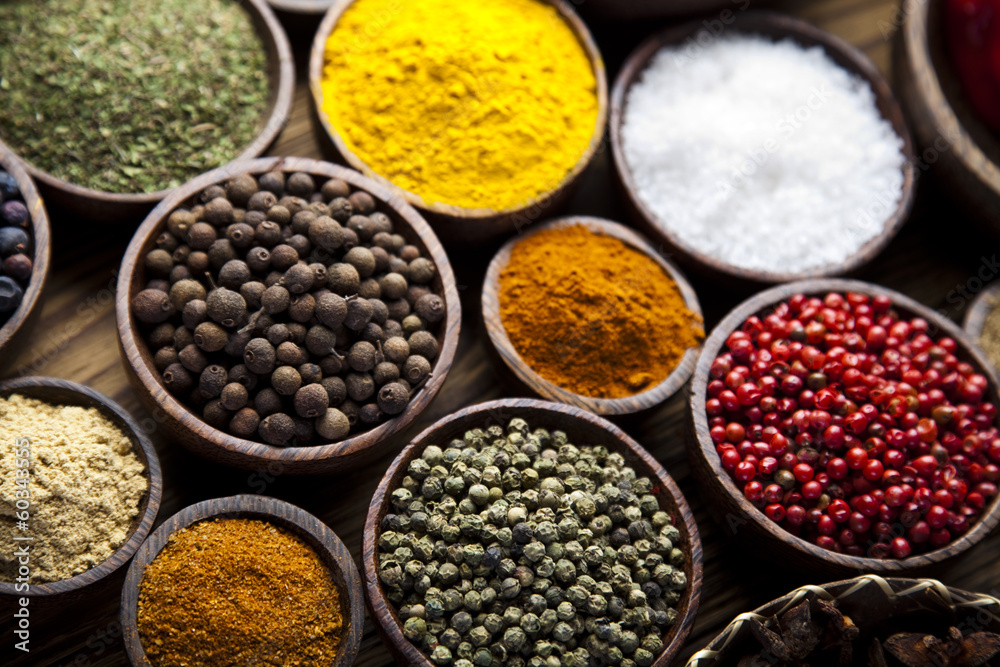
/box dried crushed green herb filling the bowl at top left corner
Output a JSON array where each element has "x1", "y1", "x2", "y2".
[{"x1": 0, "y1": 0, "x2": 269, "y2": 192}]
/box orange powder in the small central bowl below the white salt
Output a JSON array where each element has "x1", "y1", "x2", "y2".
[{"x1": 500, "y1": 225, "x2": 704, "y2": 398}]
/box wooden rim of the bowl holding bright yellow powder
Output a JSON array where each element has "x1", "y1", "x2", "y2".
[{"x1": 309, "y1": 0, "x2": 608, "y2": 222}]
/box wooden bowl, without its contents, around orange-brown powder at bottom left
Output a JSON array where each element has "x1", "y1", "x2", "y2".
[{"x1": 121, "y1": 494, "x2": 365, "y2": 667}]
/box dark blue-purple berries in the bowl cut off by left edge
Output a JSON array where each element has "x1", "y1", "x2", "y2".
[{"x1": 0, "y1": 169, "x2": 35, "y2": 326}]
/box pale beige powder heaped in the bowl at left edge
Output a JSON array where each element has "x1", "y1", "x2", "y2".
[{"x1": 0, "y1": 394, "x2": 149, "y2": 584}]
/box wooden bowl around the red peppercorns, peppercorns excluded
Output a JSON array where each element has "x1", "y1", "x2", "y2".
[{"x1": 686, "y1": 278, "x2": 1000, "y2": 574}]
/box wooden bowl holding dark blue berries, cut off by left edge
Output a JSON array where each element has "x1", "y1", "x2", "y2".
[{"x1": 0, "y1": 143, "x2": 52, "y2": 373}]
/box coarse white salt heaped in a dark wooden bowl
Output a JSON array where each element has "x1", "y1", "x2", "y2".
[{"x1": 622, "y1": 35, "x2": 905, "y2": 273}]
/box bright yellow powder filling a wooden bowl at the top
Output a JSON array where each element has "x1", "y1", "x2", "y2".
[{"x1": 322, "y1": 0, "x2": 597, "y2": 210}]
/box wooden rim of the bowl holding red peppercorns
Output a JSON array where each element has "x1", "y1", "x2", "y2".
[{"x1": 688, "y1": 278, "x2": 1000, "y2": 574}]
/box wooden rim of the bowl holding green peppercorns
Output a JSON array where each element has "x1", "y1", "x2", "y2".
[{"x1": 361, "y1": 398, "x2": 704, "y2": 667}]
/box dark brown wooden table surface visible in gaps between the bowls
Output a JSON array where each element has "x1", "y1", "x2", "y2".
[{"x1": 7, "y1": 0, "x2": 1000, "y2": 667}]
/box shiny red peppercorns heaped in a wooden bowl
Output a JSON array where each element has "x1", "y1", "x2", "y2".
[{"x1": 705, "y1": 292, "x2": 1000, "y2": 558}]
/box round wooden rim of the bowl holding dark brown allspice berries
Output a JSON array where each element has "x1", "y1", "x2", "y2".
[{"x1": 115, "y1": 157, "x2": 462, "y2": 464}]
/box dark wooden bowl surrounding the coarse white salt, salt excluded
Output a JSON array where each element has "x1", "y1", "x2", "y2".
[{"x1": 610, "y1": 11, "x2": 916, "y2": 287}]
